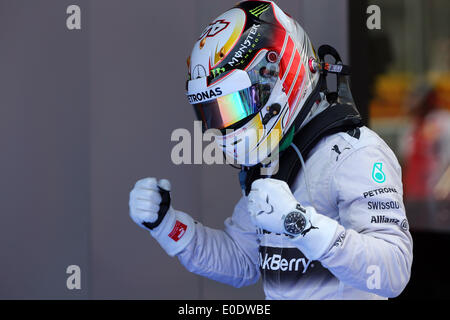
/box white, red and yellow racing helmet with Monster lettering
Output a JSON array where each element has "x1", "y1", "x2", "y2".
[{"x1": 186, "y1": 1, "x2": 320, "y2": 166}]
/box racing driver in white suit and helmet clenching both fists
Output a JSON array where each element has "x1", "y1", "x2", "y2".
[{"x1": 129, "y1": 1, "x2": 412, "y2": 299}]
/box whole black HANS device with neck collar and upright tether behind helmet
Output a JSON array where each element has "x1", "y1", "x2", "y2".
[{"x1": 239, "y1": 45, "x2": 363, "y2": 195}]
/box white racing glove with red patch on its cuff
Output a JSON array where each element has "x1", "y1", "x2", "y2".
[{"x1": 129, "y1": 178, "x2": 195, "y2": 256}]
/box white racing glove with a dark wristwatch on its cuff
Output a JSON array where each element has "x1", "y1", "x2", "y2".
[{"x1": 248, "y1": 179, "x2": 338, "y2": 260}]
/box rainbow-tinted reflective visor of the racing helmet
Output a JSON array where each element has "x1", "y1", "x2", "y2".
[{"x1": 194, "y1": 85, "x2": 262, "y2": 130}]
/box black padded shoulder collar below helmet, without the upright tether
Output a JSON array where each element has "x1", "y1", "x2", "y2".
[{"x1": 240, "y1": 104, "x2": 362, "y2": 195}]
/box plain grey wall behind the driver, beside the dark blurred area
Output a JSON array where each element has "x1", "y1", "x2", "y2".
[{"x1": 0, "y1": 0, "x2": 349, "y2": 299}]
